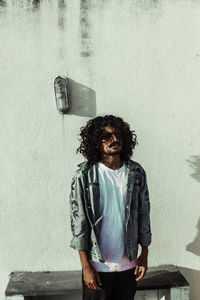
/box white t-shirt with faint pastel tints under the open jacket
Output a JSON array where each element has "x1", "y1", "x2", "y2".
[{"x1": 91, "y1": 162, "x2": 136, "y2": 272}]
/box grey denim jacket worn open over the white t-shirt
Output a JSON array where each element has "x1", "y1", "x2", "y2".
[{"x1": 70, "y1": 159, "x2": 151, "y2": 262}]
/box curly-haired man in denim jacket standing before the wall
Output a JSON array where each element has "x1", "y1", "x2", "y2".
[{"x1": 70, "y1": 115, "x2": 151, "y2": 300}]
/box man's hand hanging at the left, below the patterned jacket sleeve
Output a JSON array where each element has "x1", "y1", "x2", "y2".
[{"x1": 83, "y1": 265, "x2": 102, "y2": 290}]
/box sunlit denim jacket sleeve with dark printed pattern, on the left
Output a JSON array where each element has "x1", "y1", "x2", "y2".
[{"x1": 69, "y1": 173, "x2": 89, "y2": 250}]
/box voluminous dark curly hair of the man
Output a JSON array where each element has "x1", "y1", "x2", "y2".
[{"x1": 76, "y1": 115, "x2": 138, "y2": 164}]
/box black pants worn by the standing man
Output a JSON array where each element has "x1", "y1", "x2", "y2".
[{"x1": 82, "y1": 268, "x2": 137, "y2": 300}]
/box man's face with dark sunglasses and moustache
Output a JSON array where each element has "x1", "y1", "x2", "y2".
[{"x1": 100, "y1": 126, "x2": 123, "y2": 155}]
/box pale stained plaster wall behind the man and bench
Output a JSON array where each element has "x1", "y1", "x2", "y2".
[{"x1": 0, "y1": 0, "x2": 200, "y2": 300}]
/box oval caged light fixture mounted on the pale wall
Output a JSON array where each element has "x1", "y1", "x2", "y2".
[{"x1": 54, "y1": 76, "x2": 70, "y2": 113}]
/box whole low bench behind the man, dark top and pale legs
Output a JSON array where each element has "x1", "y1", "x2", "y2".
[{"x1": 5, "y1": 265, "x2": 189, "y2": 300}]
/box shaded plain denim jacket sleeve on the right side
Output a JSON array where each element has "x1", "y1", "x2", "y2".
[{"x1": 138, "y1": 169, "x2": 151, "y2": 246}]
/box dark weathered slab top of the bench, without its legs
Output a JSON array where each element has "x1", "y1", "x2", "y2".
[{"x1": 5, "y1": 265, "x2": 189, "y2": 300}]
